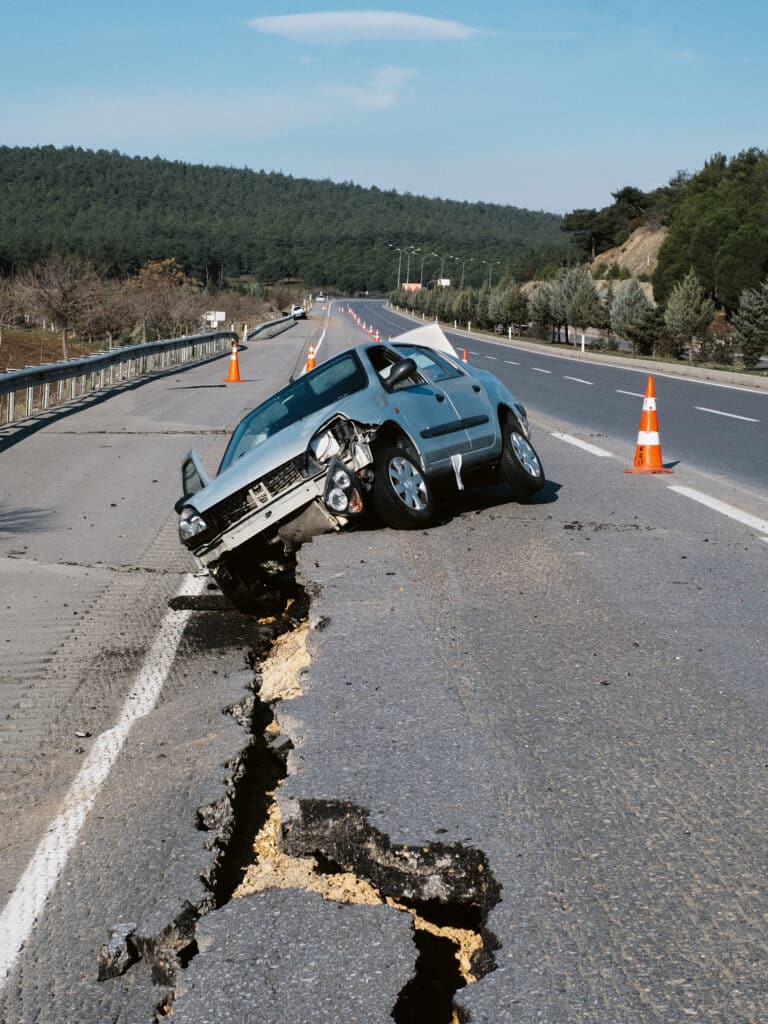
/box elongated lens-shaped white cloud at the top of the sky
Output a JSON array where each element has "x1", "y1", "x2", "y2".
[{"x1": 248, "y1": 10, "x2": 478, "y2": 43}]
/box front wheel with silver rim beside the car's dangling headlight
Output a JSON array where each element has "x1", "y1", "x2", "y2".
[{"x1": 373, "y1": 441, "x2": 434, "y2": 529}]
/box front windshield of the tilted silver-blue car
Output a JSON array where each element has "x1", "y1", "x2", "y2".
[{"x1": 219, "y1": 352, "x2": 368, "y2": 472}]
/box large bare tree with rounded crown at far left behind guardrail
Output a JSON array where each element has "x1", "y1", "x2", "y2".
[{"x1": 18, "y1": 254, "x2": 100, "y2": 359}]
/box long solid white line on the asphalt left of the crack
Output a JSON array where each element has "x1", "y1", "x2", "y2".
[{"x1": 0, "y1": 575, "x2": 208, "y2": 992}]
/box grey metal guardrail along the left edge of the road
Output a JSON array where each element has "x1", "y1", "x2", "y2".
[{"x1": 0, "y1": 316, "x2": 294, "y2": 426}]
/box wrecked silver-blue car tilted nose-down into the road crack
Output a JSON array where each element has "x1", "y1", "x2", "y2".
[{"x1": 176, "y1": 325, "x2": 545, "y2": 611}]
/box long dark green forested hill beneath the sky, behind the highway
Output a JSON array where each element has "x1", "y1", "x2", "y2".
[{"x1": 0, "y1": 146, "x2": 567, "y2": 292}]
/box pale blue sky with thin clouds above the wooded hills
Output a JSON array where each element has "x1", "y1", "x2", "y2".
[{"x1": 0, "y1": 0, "x2": 768, "y2": 212}]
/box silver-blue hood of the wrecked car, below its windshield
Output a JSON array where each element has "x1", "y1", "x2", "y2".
[{"x1": 187, "y1": 404, "x2": 362, "y2": 512}]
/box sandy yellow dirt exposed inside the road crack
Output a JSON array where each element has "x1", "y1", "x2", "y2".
[{"x1": 232, "y1": 624, "x2": 482, "y2": 987}]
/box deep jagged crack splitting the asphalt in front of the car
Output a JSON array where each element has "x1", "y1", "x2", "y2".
[{"x1": 98, "y1": 588, "x2": 500, "y2": 1024}]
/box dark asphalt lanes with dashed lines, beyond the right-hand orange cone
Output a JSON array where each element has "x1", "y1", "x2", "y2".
[{"x1": 351, "y1": 300, "x2": 768, "y2": 494}]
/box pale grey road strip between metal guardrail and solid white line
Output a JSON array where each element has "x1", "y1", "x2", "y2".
[{"x1": 0, "y1": 325, "x2": 313, "y2": 980}]
